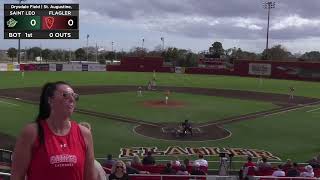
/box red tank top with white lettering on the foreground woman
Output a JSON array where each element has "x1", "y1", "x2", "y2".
[{"x1": 27, "y1": 121, "x2": 86, "y2": 180}]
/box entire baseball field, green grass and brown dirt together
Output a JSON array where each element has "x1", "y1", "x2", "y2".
[{"x1": 0, "y1": 72, "x2": 320, "y2": 166}]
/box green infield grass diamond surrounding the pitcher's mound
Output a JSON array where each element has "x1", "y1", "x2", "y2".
[{"x1": 78, "y1": 92, "x2": 277, "y2": 123}]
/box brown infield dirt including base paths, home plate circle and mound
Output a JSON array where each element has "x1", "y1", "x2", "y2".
[{"x1": 0, "y1": 86, "x2": 320, "y2": 145}]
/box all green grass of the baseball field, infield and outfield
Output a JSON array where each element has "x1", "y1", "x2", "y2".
[{"x1": 0, "y1": 72, "x2": 320, "y2": 162}]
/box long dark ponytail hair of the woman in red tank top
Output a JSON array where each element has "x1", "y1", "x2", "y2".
[{"x1": 36, "y1": 81, "x2": 70, "y2": 144}]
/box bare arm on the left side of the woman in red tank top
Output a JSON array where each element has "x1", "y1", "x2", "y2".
[{"x1": 10, "y1": 123, "x2": 37, "y2": 180}]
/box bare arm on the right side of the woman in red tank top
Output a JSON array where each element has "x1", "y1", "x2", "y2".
[{"x1": 79, "y1": 126, "x2": 97, "y2": 180}]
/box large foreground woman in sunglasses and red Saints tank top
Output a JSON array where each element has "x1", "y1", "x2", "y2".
[{"x1": 11, "y1": 81, "x2": 96, "y2": 180}]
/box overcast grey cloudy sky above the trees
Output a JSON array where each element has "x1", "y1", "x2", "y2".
[{"x1": 0, "y1": 0, "x2": 320, "y2": 53}]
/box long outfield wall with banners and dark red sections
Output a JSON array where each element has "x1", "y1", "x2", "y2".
[{"x1": 0, "y1": 57, "x2": 320, "y2": 81}]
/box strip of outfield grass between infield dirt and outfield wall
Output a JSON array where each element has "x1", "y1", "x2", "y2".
[{"x1": 0, "y1": 72, "x2": 320, "y2": 98}]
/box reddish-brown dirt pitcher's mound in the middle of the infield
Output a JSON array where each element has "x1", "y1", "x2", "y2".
[{"x1": 143, "y1": 100, "x2": 186, "y2": 108}]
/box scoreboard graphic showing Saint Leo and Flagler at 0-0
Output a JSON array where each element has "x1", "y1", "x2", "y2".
[{"x1": 4, "y1": 4, "x2": 79, "y2": 39}]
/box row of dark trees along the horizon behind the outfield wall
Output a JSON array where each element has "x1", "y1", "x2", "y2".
[{"x1": 7, "y1": 42, "x2": 320, "y2": 67}]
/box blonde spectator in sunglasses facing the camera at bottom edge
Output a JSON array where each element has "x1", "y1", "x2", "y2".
[{"x1": 109, "y1": 161, "x2": 129, "y2": 180}]
